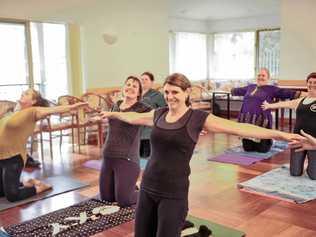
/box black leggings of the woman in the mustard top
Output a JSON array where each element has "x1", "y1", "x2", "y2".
[{"x1": 0, "y1": 155, "x2": 36, "y2": 202}]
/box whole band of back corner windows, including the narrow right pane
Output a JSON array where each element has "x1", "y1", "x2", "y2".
[{"x1": 169, "y1": 29, "x2": 280, "y2": 83}]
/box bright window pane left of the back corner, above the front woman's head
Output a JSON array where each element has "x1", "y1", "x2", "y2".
[{"x1": 170, "y1": 32, "x2": 207, "y2": 81}]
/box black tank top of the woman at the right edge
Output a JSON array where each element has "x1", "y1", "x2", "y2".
[{"x1": 294, "y1": 98, "x2": 316, "y2": 137}]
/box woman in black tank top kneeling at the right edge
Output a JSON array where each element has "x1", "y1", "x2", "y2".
[{"x1": 263, "y1": 72, "x2": 316, "y2": 180}]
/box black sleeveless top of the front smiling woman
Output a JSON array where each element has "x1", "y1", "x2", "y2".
[{"x1": 142, "y1": 108, "x2": 208, "y2": 199}]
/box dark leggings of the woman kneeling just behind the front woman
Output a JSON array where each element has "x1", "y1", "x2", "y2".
[{"x1": 99, "y1": 157, "x2": 140, "y2": 207}]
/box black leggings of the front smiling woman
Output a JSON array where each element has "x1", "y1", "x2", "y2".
[{"x1": 135, "y1": 190, "x2": 188, "y2": 237}]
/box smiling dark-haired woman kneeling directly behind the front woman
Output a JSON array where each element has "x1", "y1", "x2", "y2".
[{"x1": 100, "y1": 76, "x2": 151, "y2": 206}]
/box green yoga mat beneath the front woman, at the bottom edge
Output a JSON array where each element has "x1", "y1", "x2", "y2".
[{"x1": 187, "y1": 216, "x2": 246, "y2": 237}]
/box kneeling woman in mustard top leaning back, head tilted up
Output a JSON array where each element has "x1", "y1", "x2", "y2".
[{"x1": 0, "y1": 89, "x2": 86, "y2": 202}]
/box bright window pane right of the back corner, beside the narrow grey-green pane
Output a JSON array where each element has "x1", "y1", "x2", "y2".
[{"x1": 210, "y1": 32, "x2": 255, "y2": 80}]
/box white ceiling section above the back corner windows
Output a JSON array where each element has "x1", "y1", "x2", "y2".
[{"x1": 168, "y1": 0, "x2": 281, "y2": 21}]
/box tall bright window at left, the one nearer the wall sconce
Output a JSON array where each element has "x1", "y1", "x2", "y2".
[{"x1": 31, "y1": 23, "x2": 69, "y2": 100}]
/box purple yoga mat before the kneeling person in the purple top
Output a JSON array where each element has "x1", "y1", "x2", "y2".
[{"x1": 208, "y1": 154, "x2": 264, "y2": 165}]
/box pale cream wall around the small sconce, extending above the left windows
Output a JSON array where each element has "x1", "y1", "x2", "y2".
[{"x1": 0, "y1": 0, "x2": 169, "y2": 93}]
